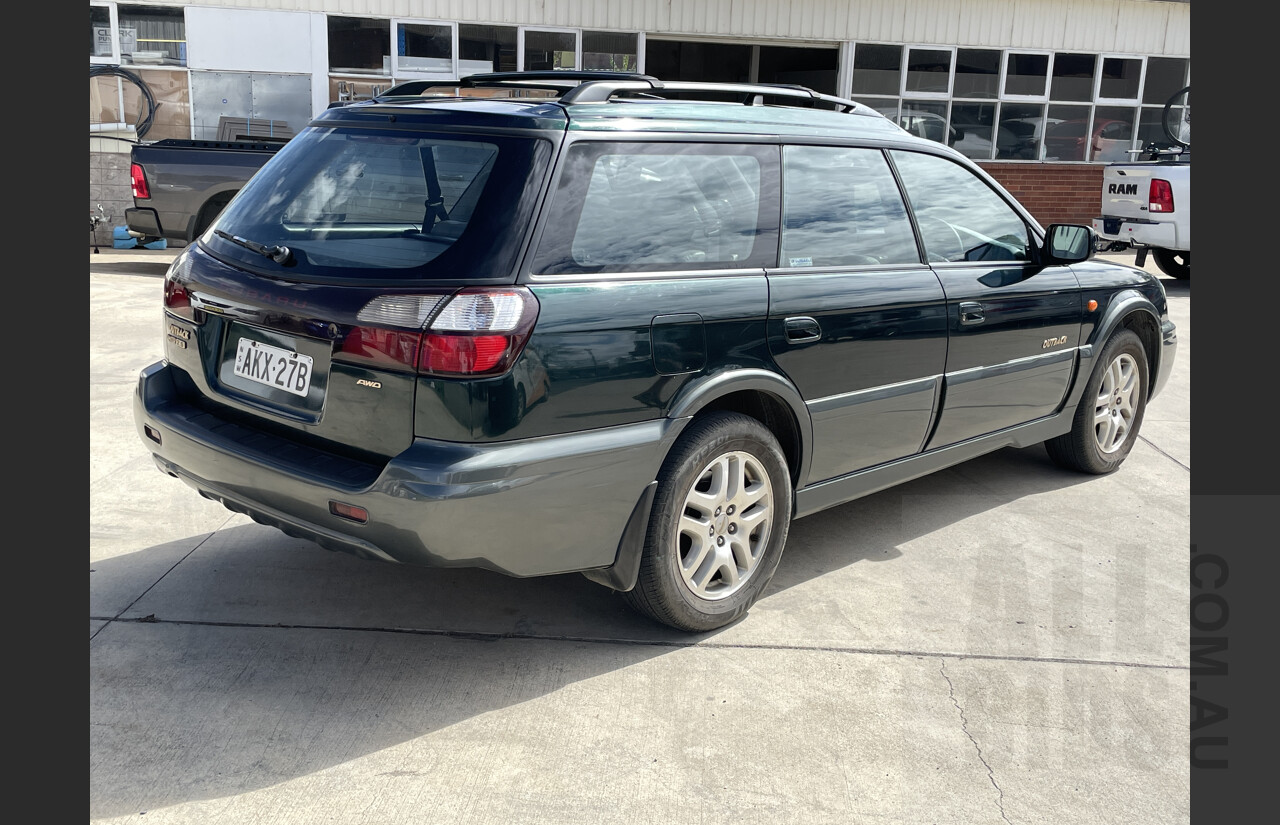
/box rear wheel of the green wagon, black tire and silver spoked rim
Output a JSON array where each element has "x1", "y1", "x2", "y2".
[{"x1": 622, "y1": 412, "x2": 791, "y2": 633}]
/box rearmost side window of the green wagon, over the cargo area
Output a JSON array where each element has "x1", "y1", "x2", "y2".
[{"x1": 534, "y1": 142, "x2": 778, "y2": 275}]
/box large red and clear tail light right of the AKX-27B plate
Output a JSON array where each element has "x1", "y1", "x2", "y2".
[{"x1": 337, "y1": 287, "x2": 538, "y2": 377}]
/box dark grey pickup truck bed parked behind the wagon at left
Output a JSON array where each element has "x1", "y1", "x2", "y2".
[{"x1": 124, "y1": 138, "x2": 285, "y2": 243}]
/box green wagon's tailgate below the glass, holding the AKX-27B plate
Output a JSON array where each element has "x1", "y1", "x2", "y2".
[{"x1": 165, "y1": 247, "x2": 417, "y2": 458}]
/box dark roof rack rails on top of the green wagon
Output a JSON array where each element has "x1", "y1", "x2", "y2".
[{"x1": 374, "y1": 69, "x2": 874, "y2": 114}]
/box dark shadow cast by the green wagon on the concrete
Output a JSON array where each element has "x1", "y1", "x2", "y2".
[{"x1": 90, "y1": 448, "x2": 1091, "y2": 817}]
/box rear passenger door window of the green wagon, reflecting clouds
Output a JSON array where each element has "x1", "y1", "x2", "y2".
[{"x1": 781, "y1": 146, "x2": 920, "y2": 266}]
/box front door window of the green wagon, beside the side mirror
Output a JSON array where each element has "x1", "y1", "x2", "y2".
[{"x1": 890, "y1": 150, "x2": 1030, "y2": 262}]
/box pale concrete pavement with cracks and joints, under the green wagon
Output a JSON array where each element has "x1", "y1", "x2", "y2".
[{"x1": 90, "y1": 249, "x2": 1190, "y2": 825}]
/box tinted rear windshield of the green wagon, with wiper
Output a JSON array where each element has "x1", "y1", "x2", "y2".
[{"x1": 201, "y1": 128, "x2": 550, "y2": 280}]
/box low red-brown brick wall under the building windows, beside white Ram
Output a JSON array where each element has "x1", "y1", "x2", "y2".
[{"x1": 979, "y1": 162, "x2": 1103, "y2": 226}]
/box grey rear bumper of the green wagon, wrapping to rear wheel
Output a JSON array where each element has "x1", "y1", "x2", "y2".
[{"x1": 133, "y1": 362, "x2": 684, "y2": 576}]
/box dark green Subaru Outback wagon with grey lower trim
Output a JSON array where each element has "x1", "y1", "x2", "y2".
[{"x1": 134, "y1": 72, "x2": 1176, "y2": 632}]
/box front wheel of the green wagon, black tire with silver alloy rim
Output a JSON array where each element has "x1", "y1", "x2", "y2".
[{"x1": 1044, "y1": 329, "x2": 1148, "y2": 476}]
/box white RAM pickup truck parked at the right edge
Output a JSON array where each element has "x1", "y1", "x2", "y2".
[{"x1": 1093, "y1": 160, "x2": 1192, "y2": 279}]
